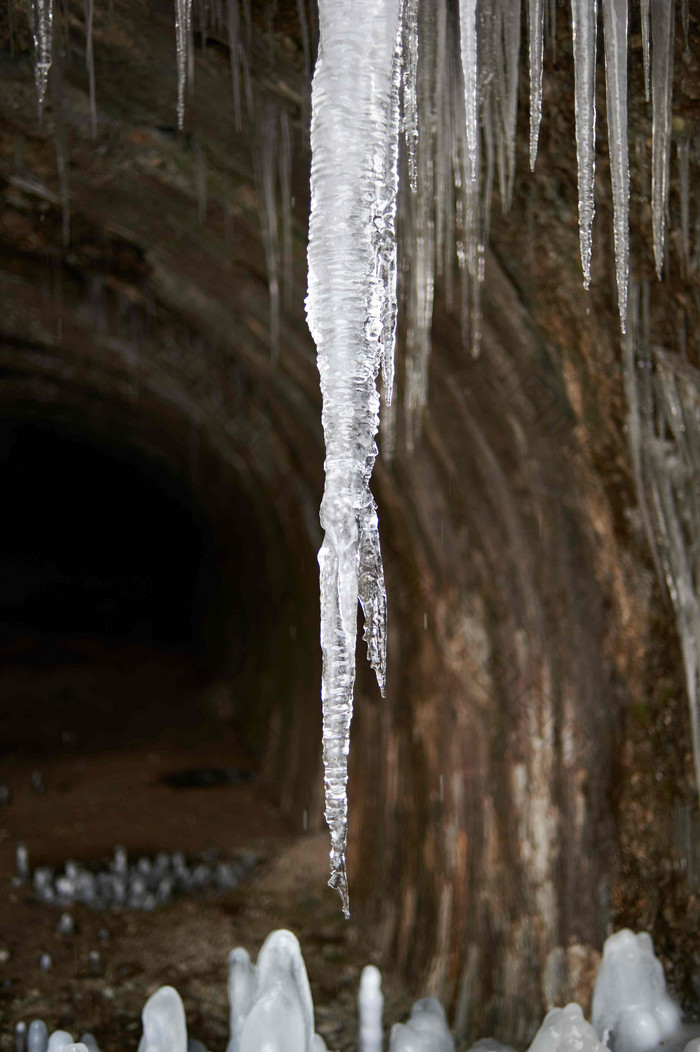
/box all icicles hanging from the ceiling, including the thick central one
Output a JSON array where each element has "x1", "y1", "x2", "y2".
[{"x1": 24, "y1": 0, "x2": 700, "y2": 909}]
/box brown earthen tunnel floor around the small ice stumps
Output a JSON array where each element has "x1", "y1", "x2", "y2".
[{"x1": 0, "y1": 639, "x2": 411, "y2": 1052}]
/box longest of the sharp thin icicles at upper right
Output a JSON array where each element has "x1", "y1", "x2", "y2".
[{"x1": 603, "y1": 0, "x2": 629, "y2": 332}]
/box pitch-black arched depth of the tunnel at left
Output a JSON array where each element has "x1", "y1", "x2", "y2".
[{"x1": 0, "y1": 421, "x2": 217, "y2": 656}]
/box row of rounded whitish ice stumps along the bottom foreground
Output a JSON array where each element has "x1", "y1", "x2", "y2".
[{"x1": 9, "y1": 930, "x2": 700, "y2": 1052}]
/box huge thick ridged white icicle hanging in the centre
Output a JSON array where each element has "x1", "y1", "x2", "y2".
[{"x1": 306, "y1": 0, "x2": 401, "y2": 913}]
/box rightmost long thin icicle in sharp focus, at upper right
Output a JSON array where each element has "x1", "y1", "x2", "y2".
[{"x1": 652, "y1": 0, "x2": 675, "y2": 278}]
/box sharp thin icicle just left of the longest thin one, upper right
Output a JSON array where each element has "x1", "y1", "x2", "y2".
[{"x1": 572, "y1": 0, "x2": 598, "y2": 288}]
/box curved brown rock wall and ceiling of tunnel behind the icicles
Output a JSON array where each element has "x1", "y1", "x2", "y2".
[{"x1": 0, "y1": 0, "x2": 700, "y2": 1043}]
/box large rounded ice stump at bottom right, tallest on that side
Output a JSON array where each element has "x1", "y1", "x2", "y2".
[{"x1": 593, "y1": 928, "x2": 681, "y2": 1052}]
